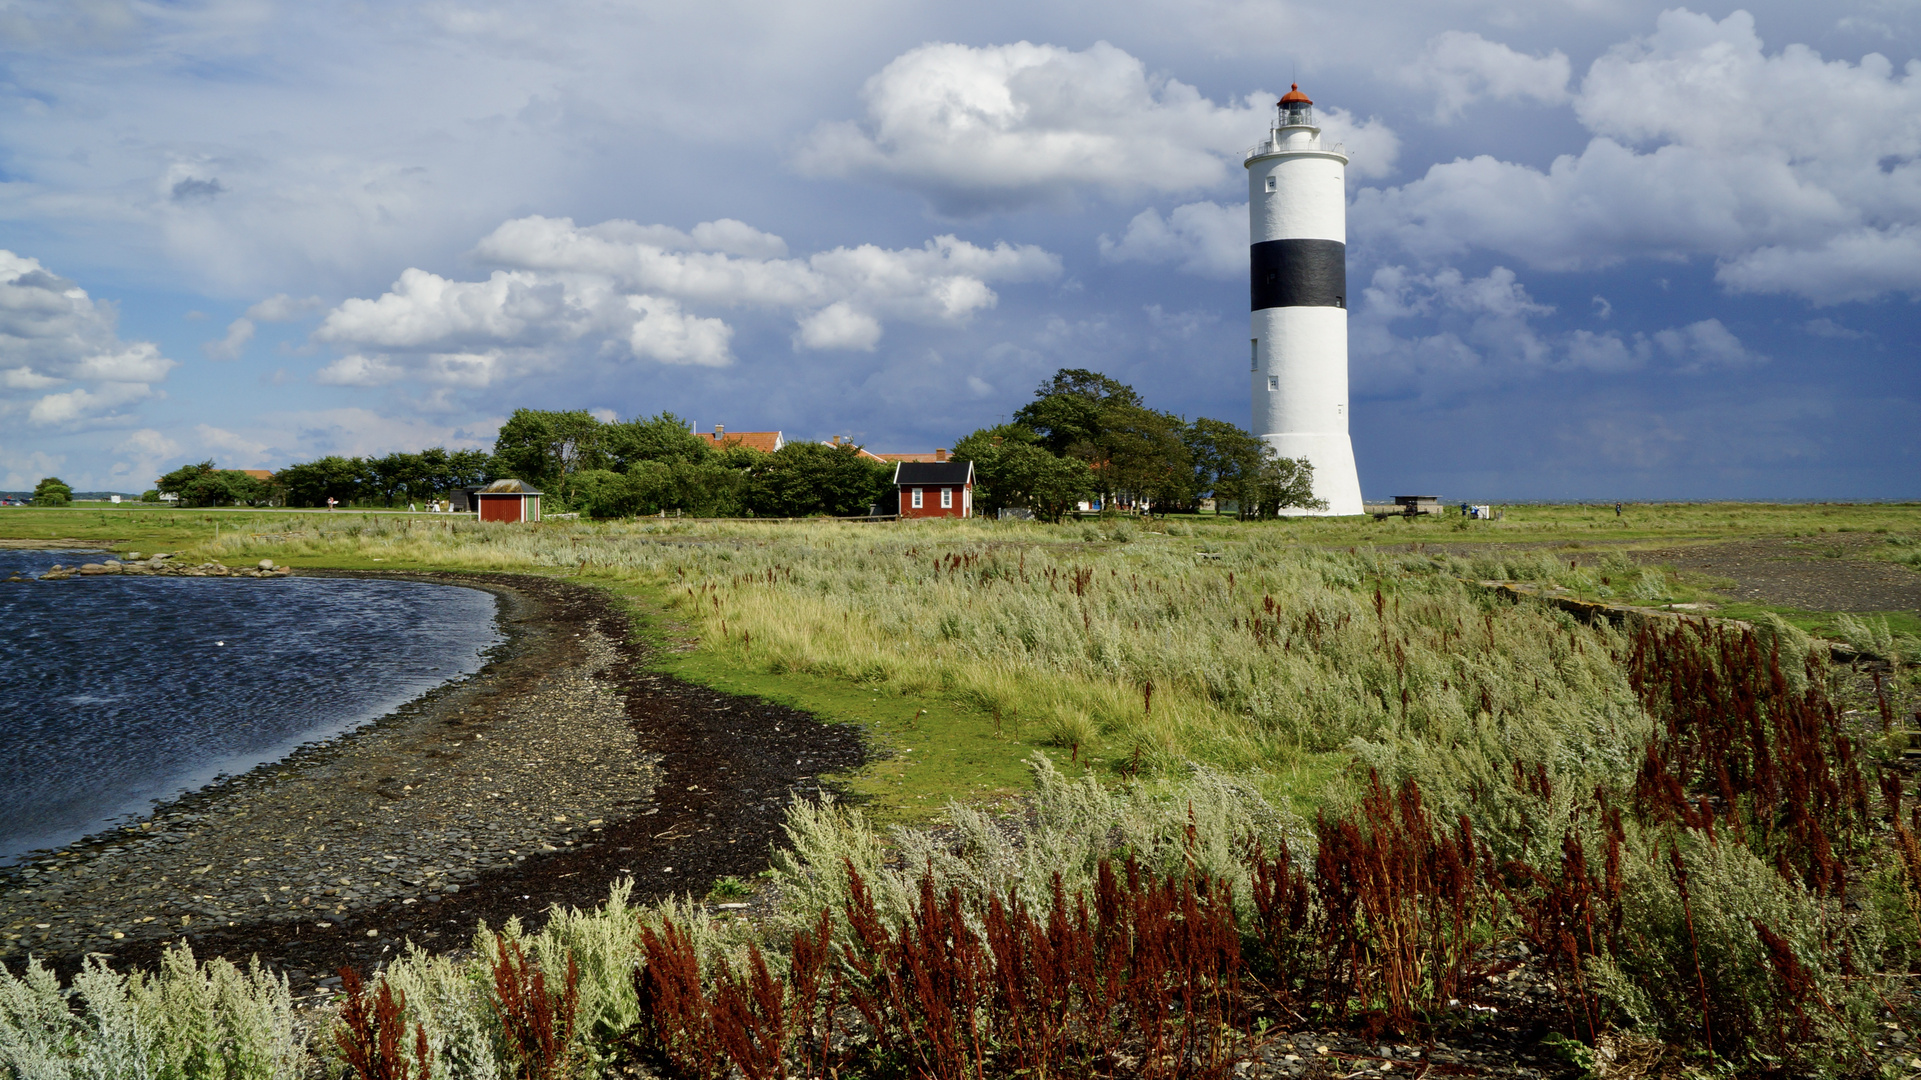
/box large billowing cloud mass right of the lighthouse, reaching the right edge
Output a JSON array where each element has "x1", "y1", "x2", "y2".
[{"x1": 1350, "y1": 10, "x2": 1921, "y2": 304}]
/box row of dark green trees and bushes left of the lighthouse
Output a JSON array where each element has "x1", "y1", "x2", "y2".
[{"x1": 150, "y1": 369, "x2": 1325, "y2": 521}]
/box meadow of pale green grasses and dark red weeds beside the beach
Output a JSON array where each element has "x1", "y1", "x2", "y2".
[{"x1": 0, "y1": 505, "x2": 1921, "y2": 1076}]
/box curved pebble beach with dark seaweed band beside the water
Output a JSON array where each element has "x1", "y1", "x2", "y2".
[{"x1": 0, "y1": 571, "x2": 866, "y2": 994}]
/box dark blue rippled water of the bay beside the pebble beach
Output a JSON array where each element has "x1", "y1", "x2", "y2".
[{"x1": 0, "y1": 550, "x2": 499, "y2": 865}]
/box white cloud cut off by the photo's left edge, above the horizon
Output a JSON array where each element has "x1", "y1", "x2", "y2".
[{"x1": 0, "y1": 250, "x2": 175, "y2": 427}]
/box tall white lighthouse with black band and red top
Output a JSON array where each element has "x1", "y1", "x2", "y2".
[{"x1": 1247, "y1": 85, "x2": 1362, "y2": 515}]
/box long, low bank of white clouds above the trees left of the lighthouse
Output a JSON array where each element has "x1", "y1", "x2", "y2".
[{"x1": 313, "y1": 217, "x2": 1060, "y2": 386}]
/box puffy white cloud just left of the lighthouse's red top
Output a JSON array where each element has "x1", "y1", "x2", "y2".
[{"x1": 793, "y1": 42, "x2": 1360, "y2": 215}]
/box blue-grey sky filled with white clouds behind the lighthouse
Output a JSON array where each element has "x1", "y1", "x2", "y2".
[{"x1": 0, "y1": 0, "x2": 1921, "y2": 502}]
